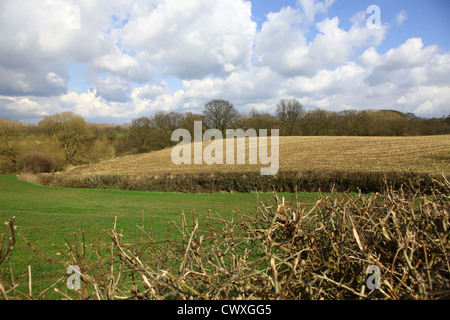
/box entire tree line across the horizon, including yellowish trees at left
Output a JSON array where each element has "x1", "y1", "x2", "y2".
[{"x1": 0, "y1": 99, "x2": 450, "y2": 173}]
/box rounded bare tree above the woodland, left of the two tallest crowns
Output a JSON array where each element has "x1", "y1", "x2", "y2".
[{"x1": 203, "y1": 100, "x2": 239, "y2": 134}]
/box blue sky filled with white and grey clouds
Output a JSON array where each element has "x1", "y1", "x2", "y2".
[{"x1": 0, "y1": 0, "x2": 450, "y2": 123}]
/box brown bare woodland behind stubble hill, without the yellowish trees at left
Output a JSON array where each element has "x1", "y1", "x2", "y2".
[{"x1": 128, "y1": 99, "x2": 450, "y2": 152}]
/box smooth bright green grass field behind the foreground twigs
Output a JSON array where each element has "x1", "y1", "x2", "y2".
[{"x1": 0, "y1": 175, "x2": 318, "y2": 298}]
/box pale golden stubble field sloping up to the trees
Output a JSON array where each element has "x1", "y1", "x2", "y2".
[{"x1": 67, "y1": 135, "x2": 450, "y2": 175}]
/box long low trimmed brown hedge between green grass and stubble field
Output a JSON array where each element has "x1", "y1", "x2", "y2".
[{"x1": 39, "y1": 171, "x2": 439, "y2": 193}]
